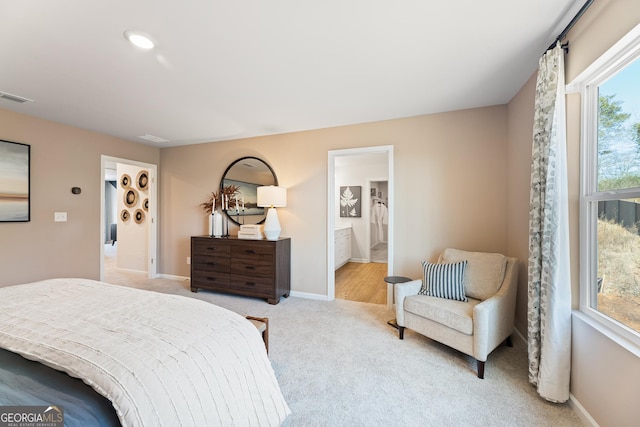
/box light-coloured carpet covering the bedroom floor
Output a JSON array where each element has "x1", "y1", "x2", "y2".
[{"x1": 105, "y1": 246, "x2": 583, "y2": 426}]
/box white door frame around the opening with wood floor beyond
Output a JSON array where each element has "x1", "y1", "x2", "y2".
[{"x1": 327, "y1": 145, "x2": 395, "y2": 301}]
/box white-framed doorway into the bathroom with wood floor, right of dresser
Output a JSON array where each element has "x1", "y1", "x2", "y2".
[{"x1": 327, "y1": 146, "x2": 393, "y2": 304}]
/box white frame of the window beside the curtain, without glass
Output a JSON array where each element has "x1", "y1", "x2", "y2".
[{"x1": 567, "y1": 24, "x2": 640, "y2": 354}]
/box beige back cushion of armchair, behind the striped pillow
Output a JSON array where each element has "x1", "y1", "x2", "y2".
[{"x1": 440, "y1": 248, "x2": 507, "y2": 301}]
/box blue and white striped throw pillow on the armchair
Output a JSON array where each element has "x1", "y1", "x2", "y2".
[{"x1": 418, "y1": 261, "x2": 467, "y2": 301}]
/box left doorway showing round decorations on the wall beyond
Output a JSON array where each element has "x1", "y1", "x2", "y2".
[{"x1": 100, "y1": 155, "x2": 158, "y2": 281}]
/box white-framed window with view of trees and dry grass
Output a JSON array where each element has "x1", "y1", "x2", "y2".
[{"x1": 578, "y1": 26, "x2": 640, "y2": 345}]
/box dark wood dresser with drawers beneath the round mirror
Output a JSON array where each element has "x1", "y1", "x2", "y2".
[{"x1": 191, "y1": 236, "x2": 291, "y2": 304}]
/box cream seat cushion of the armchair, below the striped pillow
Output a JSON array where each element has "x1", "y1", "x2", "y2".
[{"x1": 403, "y1": 295, "x2": 480, "y2": 335}]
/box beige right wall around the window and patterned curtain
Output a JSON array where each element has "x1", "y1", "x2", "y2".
[{"x1": 507, "y1": 0, "x2": 640, "y2": 426}]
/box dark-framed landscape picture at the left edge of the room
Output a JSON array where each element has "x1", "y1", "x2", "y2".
[{"x1": 0, "y1": 140, "x2": 31, "y2": 222}]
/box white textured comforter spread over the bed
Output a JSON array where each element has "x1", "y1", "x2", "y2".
[{"x1": 0, "y1": 279, "x2": 290, "y2": 427}]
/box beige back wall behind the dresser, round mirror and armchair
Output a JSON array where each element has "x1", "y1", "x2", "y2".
[{"x1": 160, "y1": 106, "x2": 507, "y2": 296}]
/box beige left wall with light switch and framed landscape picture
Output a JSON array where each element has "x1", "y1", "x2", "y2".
[{"x1": 0, "y1": 109, "x2": 159, "y2": 286}]
